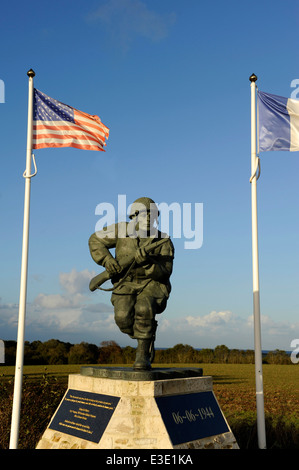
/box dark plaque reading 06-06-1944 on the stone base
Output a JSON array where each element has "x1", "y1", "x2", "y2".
[{"x1": 156, "y1": 391, "x2": 229, "y2": 445}]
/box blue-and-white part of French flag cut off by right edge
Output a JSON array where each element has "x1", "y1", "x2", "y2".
[{"x1": 257, "y1": 91, "x2": 299, "y2": 152}]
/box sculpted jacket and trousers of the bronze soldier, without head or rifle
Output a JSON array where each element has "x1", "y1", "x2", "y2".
[{"x1": 89, "y1": 222, "x2": 174, "y2": 339}]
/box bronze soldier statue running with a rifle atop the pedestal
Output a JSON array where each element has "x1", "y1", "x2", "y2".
[{"x1": 89, "y1": 197, "x2": 174, "y2": 370}]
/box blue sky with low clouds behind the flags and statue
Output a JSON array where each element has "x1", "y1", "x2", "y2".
[{"x1": 0, "y1": 0, "x2": 299, "y2": 350}]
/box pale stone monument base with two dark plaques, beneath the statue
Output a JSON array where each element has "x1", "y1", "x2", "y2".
[{"x1": 37, "y1": 367, "x2": 238, "y2": 449}]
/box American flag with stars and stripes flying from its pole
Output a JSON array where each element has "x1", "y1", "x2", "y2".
[{"x1": 32, "y1": 89, "x2": 109, "y2": 151}]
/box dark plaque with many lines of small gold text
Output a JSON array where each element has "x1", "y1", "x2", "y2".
[{"x1": 49, "y1": 389, "x2": 120, "y2": 443}]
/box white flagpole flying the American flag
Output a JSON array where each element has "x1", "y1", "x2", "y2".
[{"x1": 9, "y1": 69, "x2": 35, "y2": 449}]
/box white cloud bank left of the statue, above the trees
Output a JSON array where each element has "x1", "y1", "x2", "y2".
[{"x1": 0, "y1": 269, "x2": 117, "y2": 344}]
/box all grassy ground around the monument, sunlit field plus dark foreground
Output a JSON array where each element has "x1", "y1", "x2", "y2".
[{"x1": 0, "y1": 364, "x2": 299, "y2": 448}]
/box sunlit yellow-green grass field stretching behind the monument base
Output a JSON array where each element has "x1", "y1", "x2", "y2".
[{"x1": 0, "y1": 364, "x2": 299, "y2": 416}]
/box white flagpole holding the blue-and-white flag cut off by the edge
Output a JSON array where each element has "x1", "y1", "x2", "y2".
[{"x1": 249, "y1": 74, "x2": 266, "y2": 449}]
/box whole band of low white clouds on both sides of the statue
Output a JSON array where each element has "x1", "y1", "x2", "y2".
[{"x1": 0, "y1": 269, "x2": 299, "y2": 350}]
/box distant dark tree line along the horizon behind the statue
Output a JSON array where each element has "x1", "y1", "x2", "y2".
[{"x1": 0, "y1": 339, "x2": 292, "y2": 366}]
